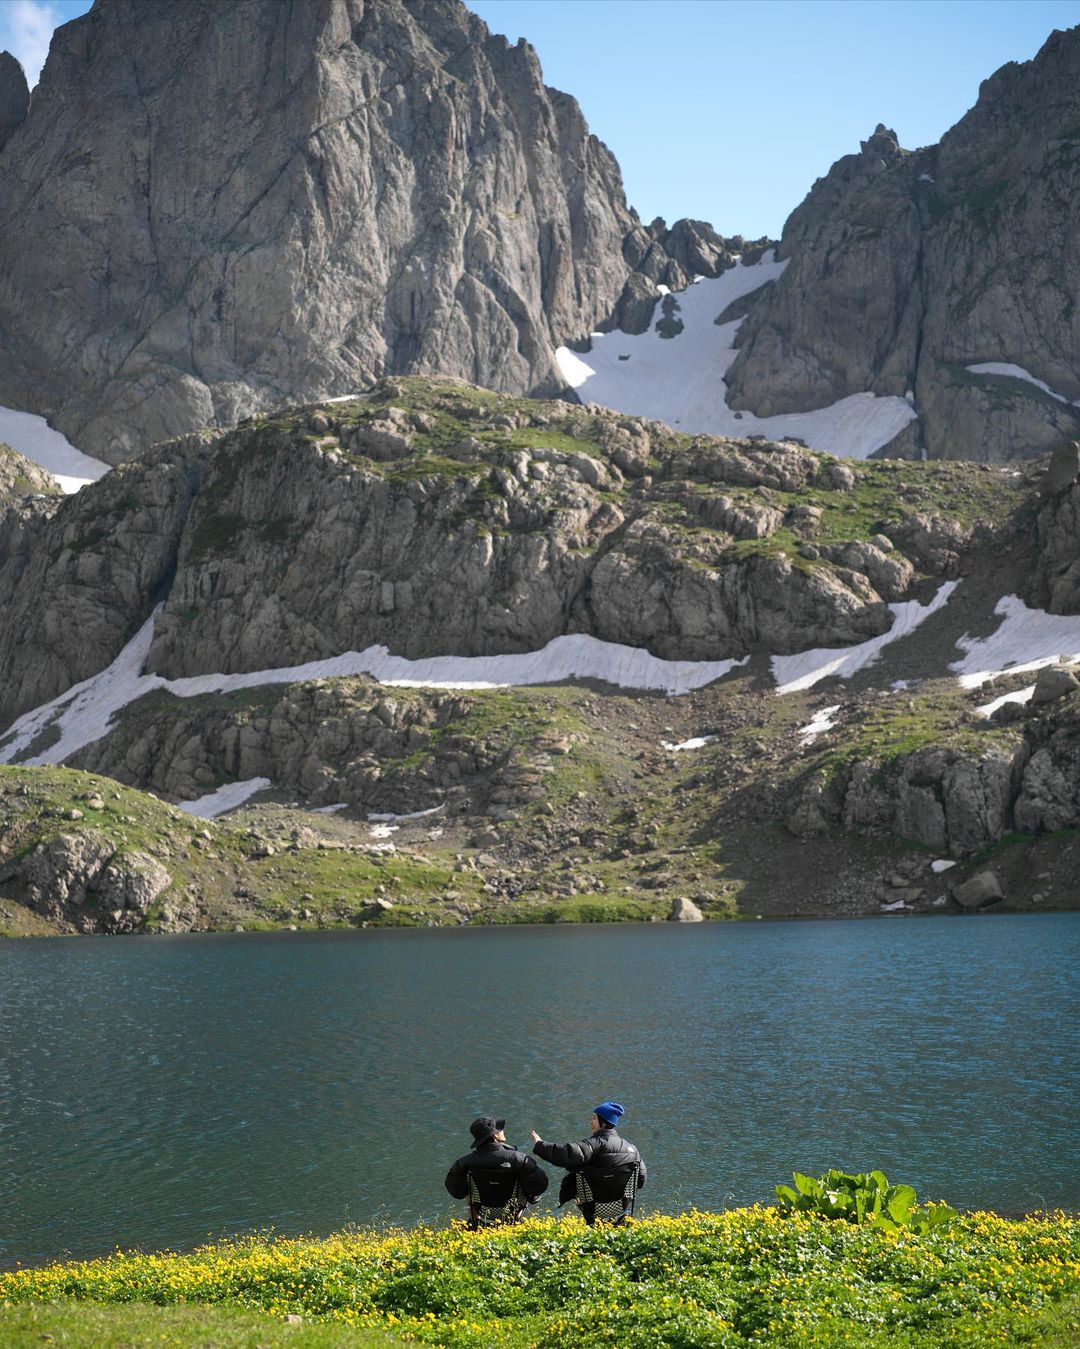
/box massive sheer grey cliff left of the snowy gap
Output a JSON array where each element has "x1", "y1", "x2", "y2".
[{"x1": 0, "y1": 0, "x2": 649, "y2": 463}]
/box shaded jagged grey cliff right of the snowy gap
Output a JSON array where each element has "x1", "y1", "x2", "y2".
[{"x1": 728, "y1": 28, "x2": 1080, "y2": 461}]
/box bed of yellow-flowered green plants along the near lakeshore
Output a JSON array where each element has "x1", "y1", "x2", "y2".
[{"x1": 0, "y1": 1207, "x2": 1080, "y2": 1349}]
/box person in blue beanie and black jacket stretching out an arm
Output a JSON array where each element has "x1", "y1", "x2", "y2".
[{"x1": 533, "y1": 1101, "x2": 647, "y2": 1226}]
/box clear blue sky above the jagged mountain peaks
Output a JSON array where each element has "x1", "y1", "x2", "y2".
[{"x1": 8, "y1": 0, "x2": 1080, "y2": 237}]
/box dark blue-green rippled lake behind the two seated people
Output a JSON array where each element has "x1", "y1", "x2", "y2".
[{"x1": 0, "y1": 913, "x2": 1080, "y2": 1265}]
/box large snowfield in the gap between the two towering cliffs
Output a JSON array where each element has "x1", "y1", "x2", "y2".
[{"x1": 556, "y1": 250, "x2": 916, "y2": 459}]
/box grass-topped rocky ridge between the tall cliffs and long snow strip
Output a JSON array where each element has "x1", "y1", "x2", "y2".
[{"x1": 0, "y1": 379, "x2": 1011, "y2": 724}]
